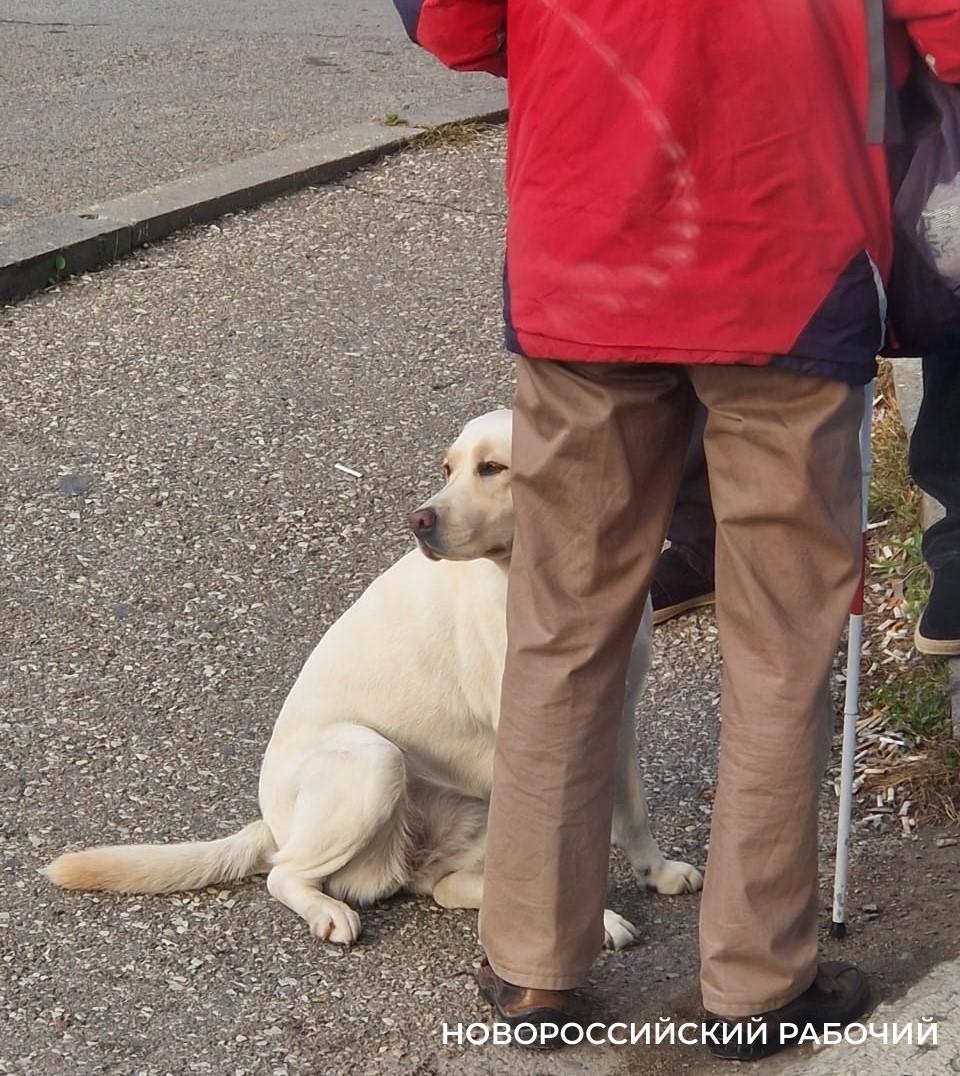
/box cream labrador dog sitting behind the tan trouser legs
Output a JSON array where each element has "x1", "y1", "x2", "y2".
[{"x1": 44, "y1": 411, "x2": 702, "y2": 949}]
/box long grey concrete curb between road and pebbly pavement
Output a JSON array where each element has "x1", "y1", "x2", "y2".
[{"x1": 0, "y1": 91, "x2": 507, "y2": 303}]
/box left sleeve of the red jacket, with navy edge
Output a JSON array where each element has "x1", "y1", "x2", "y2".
[{"x1": 394, "y1": 0, "x2": 507, "y2": 75}]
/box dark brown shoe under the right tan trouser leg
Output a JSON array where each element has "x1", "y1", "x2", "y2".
[{"x1": 706, "y1": 962, "x2": 870, "y2": 1061}]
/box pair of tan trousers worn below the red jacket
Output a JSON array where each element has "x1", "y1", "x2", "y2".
[{"x1": 480, "y1": 359, "x2": 863, "y2": 1016}]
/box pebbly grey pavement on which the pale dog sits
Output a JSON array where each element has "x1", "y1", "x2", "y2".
[{"x1": 0, "y1": 132, "x2": 957, "y2": 1076}]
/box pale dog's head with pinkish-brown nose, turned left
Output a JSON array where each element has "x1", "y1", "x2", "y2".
[{"x1": 410, "y1": 410, "x2": 513, "y2": 561}]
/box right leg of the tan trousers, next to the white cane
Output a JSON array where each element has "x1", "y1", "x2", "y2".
[{"x1": 691, "y1": 367, "x2": 863, "y2": 1017}]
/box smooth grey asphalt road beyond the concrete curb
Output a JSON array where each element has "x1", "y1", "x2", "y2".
[{"x1": 0, "y1": 0, "x2": 494, "y2": 238}]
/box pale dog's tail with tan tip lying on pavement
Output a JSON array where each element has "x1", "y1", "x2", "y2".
[{"x1": 41, "y1": 820, "x2": 277, "y2": 893}]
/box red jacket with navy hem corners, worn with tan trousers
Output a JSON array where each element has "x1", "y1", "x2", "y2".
[{"x1": 396, "y1": 0, "x2": 960, "y2": 380}]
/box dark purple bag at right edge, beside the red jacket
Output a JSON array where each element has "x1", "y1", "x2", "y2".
[{"x1": 883, "y1": 62, "x2": 960, "y2": 355}]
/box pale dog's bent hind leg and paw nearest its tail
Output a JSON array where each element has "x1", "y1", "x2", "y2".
[{"x1": 267, "y1": 725, "x2": 406, "y2": 945}]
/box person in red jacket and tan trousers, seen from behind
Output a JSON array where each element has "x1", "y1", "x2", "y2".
[{"x1": 396, "y1": 0, "x2": 960, "y2": 1060}]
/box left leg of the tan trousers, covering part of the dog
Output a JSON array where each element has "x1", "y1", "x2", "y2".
[{"x1": 480, "y1": 359, "x2": 695, "y2": 990}]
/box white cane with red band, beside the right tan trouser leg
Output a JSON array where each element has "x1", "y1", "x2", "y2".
[{"x1": 830, "y1": 382, "x2": 874, "y2": 938}]
